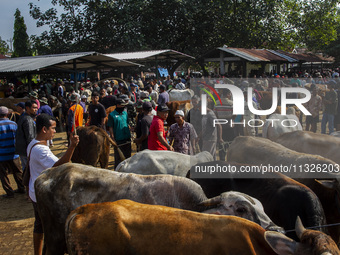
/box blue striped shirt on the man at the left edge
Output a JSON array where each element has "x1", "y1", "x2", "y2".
[{"x1": 0, "y1": 119, "x2": 19, "y2": 161}]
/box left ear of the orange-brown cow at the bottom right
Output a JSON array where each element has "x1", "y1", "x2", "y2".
[{"x1": 264, "y1": 231, "x2": 298, "y2": 255}]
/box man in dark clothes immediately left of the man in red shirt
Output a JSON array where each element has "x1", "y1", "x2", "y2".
[{"x1": 134, "y1": 101, "x2": 153, "y2": 151}]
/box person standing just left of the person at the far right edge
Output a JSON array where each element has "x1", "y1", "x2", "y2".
[{"x1": 306, "y1": 86, "x2": 322, "y2": 133}]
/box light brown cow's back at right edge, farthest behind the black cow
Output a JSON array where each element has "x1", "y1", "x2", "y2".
[{"x1": 275, "y1": 131, "x2": 340, "y2": 164}]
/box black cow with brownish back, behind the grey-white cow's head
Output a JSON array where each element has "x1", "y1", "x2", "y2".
[{"x1": 188, "y1": 161, "x2": 326, "y2": 240}]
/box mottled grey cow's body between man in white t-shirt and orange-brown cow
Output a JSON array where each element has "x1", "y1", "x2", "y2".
[{"x1": 34, "y1": 163, "x2": 280, "y2": 255}]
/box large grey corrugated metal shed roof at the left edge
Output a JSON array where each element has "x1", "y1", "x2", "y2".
[{"x1": 0, "y1": 51, "x2": 140, "y2": 73}]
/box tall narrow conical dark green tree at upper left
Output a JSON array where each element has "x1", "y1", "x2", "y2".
[{"x1": 13, "y1": 9, "x2": 31, "y2": 57}]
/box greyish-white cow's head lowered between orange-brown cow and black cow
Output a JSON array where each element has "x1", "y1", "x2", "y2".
[{"x1": 200, "y1": 191, "x2": 284, "y2": 233}]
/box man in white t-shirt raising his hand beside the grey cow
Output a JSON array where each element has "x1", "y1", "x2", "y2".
[{"x1": 27, "y1": 113, "x2": 79, "y2": 255}]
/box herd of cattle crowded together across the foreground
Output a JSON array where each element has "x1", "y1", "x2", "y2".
[{"x1": 35, "y1": 128, "x2": 340, "y2": 255}]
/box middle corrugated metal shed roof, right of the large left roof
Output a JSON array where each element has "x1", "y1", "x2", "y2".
[{"x1": 105, "y1": 50, "x2": 194, "y2": 61}]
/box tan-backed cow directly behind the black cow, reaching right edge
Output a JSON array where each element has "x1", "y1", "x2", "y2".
[{"x1": 227, "y1": 137, "x2": 340, "y2": 243}]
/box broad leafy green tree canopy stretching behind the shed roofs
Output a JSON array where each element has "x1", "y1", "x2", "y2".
[{"x1": 30, "y1": 0, "x2": 338, "y2": 56}]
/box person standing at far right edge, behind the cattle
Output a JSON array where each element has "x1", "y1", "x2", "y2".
[{"x1": 321, "y1": 82, "x2": 338, "y2": 134}]
